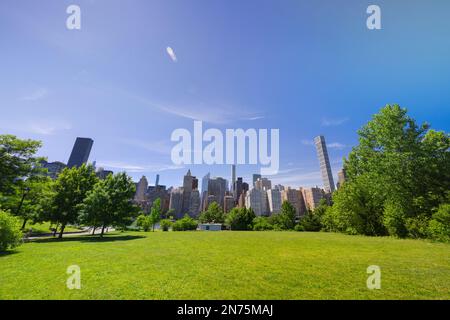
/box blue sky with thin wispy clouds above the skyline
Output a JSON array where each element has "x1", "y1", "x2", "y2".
[{"x1": 0, "y1": 0, "x2": 450, "y2": 187}]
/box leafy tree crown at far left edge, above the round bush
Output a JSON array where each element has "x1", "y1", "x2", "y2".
[{"x1": 0, "y1": 135, "x2": 41, "y2": 196}]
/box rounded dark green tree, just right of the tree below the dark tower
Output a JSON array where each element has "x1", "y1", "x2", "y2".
[{"x1": 79, "y1": 172, "x2": 138, "y2": 237}]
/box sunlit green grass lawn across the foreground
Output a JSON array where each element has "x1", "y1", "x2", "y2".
[{"x1": 0, "y1": 232, "x2": 450, "y2": 299}]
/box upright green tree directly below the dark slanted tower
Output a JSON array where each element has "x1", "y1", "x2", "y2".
[{"x1": 51, "y1": 164, "x2": 98, "y2": 238}]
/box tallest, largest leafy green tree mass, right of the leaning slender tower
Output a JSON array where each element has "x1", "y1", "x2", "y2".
[{"x1": 327, "y1": 105, "x2": 450, "y2": 237}]
